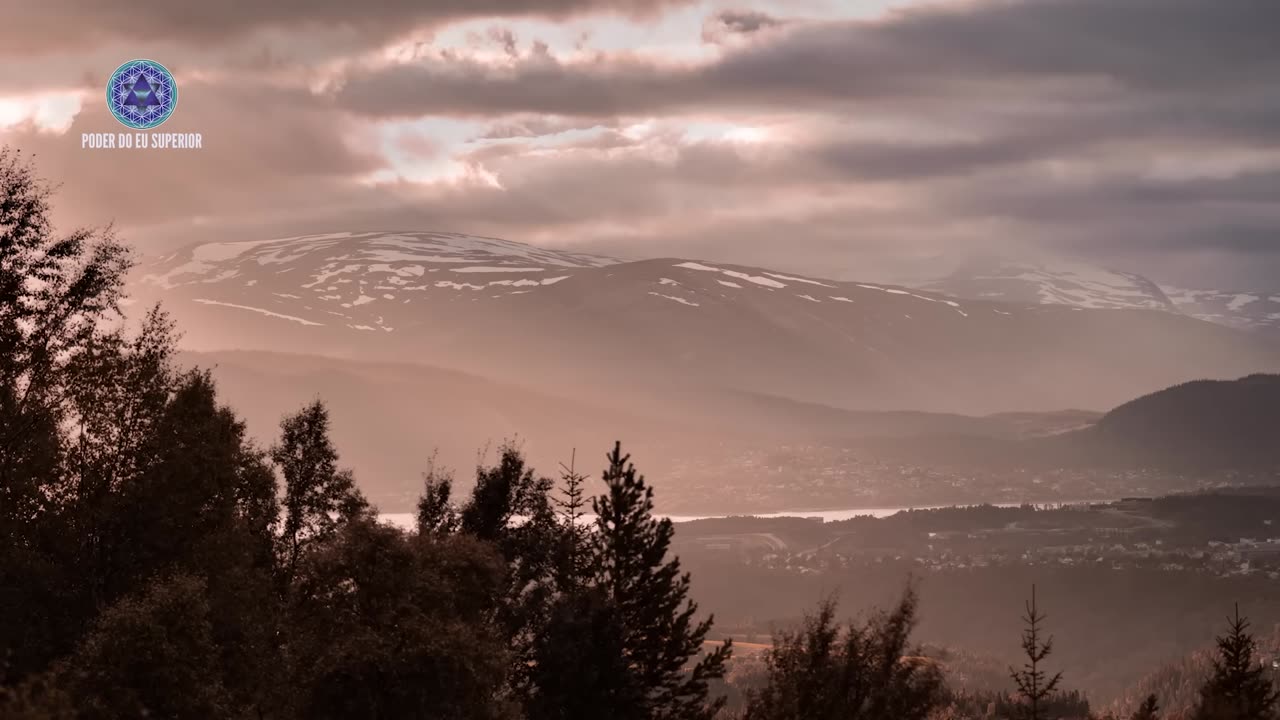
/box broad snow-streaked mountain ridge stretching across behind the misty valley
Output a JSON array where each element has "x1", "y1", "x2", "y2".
[{"x1": 132, "y1": 232, "x2": 1280, "y2": 421}]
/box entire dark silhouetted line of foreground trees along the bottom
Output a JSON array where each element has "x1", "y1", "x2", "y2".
[{"x1": 0, "y1": 151, "x2": 1276, "y2": 720}]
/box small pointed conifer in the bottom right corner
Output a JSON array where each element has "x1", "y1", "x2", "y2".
[{"x1": 1192, "y1": 605, "x2": 1280, "y2": 720}]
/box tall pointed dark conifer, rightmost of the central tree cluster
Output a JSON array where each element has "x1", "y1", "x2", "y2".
[{"x1": 591, "y1": 443, "x2": 731, "y2": 720}]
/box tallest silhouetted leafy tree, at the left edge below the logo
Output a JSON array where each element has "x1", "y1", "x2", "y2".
[{"x1": 0, "y1": 147, "x2": 129, "y2": 682}]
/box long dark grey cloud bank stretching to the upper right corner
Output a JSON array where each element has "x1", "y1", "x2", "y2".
[{"x1": 340, "y1": 0, "x2": 1280, "y2": 115}]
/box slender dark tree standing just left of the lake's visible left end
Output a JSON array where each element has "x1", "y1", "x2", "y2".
[{"x1": 271, "y1": 400, "x2": 369, "y2": 579}]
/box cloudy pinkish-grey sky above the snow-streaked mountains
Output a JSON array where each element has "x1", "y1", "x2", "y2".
[{"x1": 0, "y1": 0, "x2": 1280, "y2": 290}]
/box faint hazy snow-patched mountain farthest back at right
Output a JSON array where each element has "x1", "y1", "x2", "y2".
[{"x1": 919, "y1": 259, "x2": 1280, "y2": 337}]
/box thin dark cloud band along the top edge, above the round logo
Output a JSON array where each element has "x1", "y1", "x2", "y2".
[{"x1": 0, "y1": 0, "x2": 687, "y2": 55}]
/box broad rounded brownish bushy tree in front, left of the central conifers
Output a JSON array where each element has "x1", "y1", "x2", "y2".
[{"x1": 289, "y1": 518, "x2": 509, "y2": 720}]
